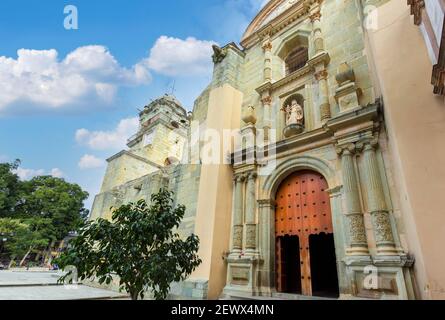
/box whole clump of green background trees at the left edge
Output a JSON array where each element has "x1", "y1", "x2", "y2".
[{"x1": 0, "y1": 160, "x2": 88, "y2": 258}]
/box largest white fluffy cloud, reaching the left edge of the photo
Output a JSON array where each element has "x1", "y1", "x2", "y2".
[{"x1": 0, "y1": 45, "x2": 150, "y2": 113}]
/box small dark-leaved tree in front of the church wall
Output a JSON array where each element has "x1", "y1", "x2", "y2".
[{"x1": 57, "y1": 190, "x2": 201, "y2": 300}]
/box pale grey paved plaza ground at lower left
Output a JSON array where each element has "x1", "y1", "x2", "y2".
[{"x1": 0, "y1": 271, "x2": 126, "y2": 300}]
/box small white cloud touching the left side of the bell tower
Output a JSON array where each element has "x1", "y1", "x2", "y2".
[{"x1": 76, "y1": 117, "x2": 139, "y2": 150}]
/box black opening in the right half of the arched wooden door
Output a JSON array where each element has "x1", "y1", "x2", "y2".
[{"x1": 309, "y1": 233, "x2": 339, "y2": 298}]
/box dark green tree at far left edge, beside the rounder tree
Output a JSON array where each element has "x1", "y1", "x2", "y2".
[{"x1": 0, "y1": 160, "x2": 22, "y2": 218}]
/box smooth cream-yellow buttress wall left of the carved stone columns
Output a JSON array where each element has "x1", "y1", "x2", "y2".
[{"x1": 192, "y1": 84, "x2": 242, "y2": 299}]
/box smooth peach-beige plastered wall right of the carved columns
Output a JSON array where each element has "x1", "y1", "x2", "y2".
[{"x1": 369, "y1": 0, "x2": 445, "y2": 299}]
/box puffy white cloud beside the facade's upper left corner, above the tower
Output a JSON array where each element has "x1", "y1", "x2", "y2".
[{"x1": 146, "y1": 36, "x2": 216, "y2": 76}]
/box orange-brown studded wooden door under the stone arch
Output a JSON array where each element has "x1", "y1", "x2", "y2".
[{"x1": 275, "y1": 171, "x2": 338, "y2": 296}]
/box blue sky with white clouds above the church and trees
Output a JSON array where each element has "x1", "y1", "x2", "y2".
[{"x1": 0, "y1": 0, "x2": 264, "y2": 207}]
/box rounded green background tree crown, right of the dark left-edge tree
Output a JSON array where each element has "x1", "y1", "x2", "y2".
[{"x1": 17, "y1": 176, "x2": 89, "y2": 240}]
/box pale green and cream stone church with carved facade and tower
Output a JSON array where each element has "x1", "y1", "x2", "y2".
[{"x1": 91, "y1": 0, "x2": 445, "y2": 299}]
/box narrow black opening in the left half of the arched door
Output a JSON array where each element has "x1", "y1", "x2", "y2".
[{"x1": 278, "y1": 236, "x2": 301, "y2": 294}]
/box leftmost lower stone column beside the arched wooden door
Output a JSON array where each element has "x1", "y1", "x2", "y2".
[{"x1": 232, "y1": 175, "x2": 245, "y2": 253}]
